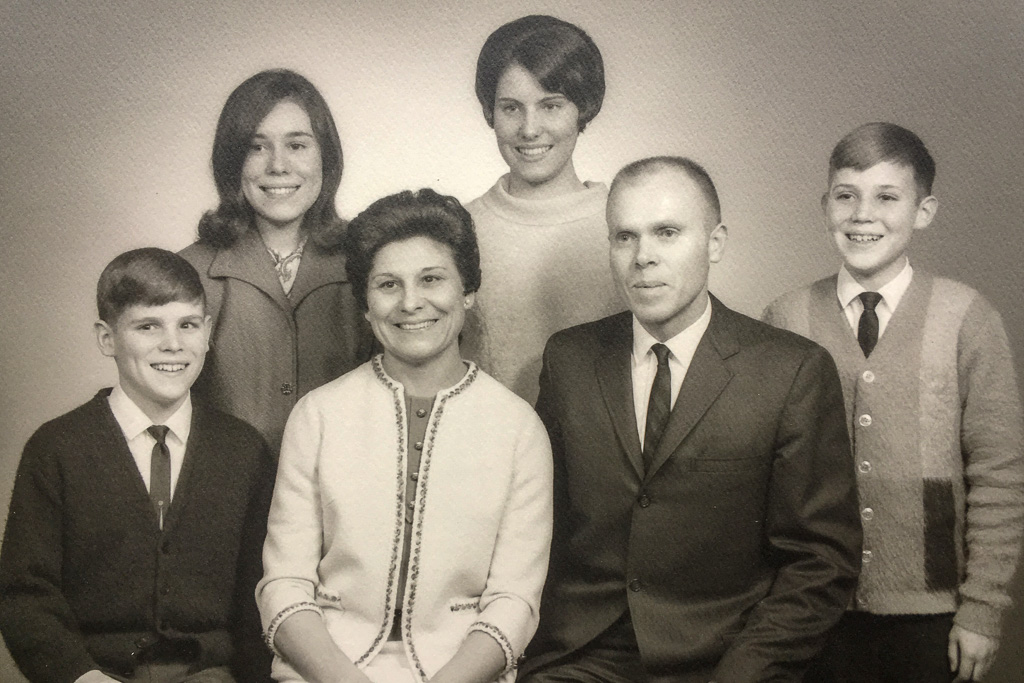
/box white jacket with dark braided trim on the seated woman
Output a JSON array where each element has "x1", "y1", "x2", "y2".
[{"x1": 256, "y1": 356, "x2": 552, "y2": 681}]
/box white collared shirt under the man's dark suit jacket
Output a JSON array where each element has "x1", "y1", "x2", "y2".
[{"x1": 630, "y1": 298, "x2": 711, "y2": 446}]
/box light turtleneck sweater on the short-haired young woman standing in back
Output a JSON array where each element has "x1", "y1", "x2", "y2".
[{"x1": 462, "y1": 174, "x2": 625, "y2": 403}]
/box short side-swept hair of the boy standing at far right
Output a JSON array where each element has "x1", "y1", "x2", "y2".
[{"x1": 828, "y1": 122, "x2": 935, "y2": 200}]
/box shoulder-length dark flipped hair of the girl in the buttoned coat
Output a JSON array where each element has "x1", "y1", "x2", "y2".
[{"x1": 199, "y1": 69, "x2": 344, "y2": 251}]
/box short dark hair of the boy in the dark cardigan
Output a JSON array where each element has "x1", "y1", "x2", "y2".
[{"x1": 96, "y1": 247, "x2": 206, "y2": 325}]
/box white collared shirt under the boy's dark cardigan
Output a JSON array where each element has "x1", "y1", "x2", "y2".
[{"x1": 108, "y1": 384, "x2": 191, "y2": 500}]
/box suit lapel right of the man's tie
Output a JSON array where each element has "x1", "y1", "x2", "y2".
[{"x1": 647, "y1": 297, "x2": 739, "y2": 479}]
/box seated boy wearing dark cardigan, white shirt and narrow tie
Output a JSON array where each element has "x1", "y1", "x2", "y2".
[{"x1": 0, "y1": 249, "x2": 273, "y2": 683}]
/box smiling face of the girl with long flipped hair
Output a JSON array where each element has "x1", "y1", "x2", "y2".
[{"x1": 242, "y1": 99, "x2": 324, "y2": 230}]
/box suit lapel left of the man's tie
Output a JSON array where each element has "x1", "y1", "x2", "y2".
[{"x1": 594, "y1": 312, "x2": 643, "y2": 478}]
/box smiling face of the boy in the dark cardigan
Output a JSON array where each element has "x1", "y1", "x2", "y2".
[{"x1": 95, "y1": 300, "x2": 210, "y2": 424}]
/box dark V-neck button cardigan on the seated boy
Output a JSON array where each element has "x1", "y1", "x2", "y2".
[{"x1": 0, "y1": 389, "x2": 273, "y2": 683}]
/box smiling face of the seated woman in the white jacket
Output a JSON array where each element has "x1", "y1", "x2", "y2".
[{"x1": 366, "y1": 237, "x2": 474, "y2": 381}]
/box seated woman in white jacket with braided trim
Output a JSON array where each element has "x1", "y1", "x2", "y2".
[{"x1": 256, "y1": 189, "x2": 552, "y2": 683}]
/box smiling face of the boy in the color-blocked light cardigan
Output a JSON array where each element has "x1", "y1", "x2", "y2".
[{"x1": 821, "y1": 162, "x2": 938, "y2": 291}]
